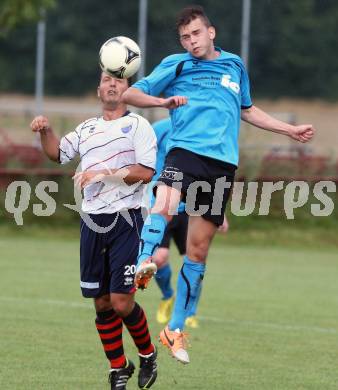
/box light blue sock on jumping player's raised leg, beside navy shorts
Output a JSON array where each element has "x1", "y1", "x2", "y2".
[{"x1": 137, "y1": 214, "x2": 168, "y2": 265}]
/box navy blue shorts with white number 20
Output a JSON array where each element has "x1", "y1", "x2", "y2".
[{"x1": 80, "y1": 209, "x2": 143, "y2": 298}]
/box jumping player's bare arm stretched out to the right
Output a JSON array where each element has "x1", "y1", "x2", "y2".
[{"x1": 241, "y1": 106, "x2": 315, "y2": 143}]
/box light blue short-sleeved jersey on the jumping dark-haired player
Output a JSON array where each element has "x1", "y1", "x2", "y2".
[{"x1": 133, "y1": 48, "x2": 252, "y2": 165}]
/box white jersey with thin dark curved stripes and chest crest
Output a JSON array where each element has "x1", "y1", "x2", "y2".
[{"x1": 60, "y1": 112, "x2": 157, "y2": 214}]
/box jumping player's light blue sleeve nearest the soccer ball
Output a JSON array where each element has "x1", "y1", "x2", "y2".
[{"x1": 132, "y1": 56, "x2": 178, "y2": 96}]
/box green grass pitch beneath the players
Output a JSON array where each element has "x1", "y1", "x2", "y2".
[{"x1": 0, "y1": 235, "x2": 338, "y2": 390}]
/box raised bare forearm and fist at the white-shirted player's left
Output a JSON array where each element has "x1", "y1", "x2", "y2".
[{"x1": 30, "y1": 115, "x2": 60, "y2": 161}]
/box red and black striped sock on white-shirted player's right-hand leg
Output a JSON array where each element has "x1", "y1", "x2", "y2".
[{"x1": 122, "y1": 302, "x2": 154, "y2": 355}]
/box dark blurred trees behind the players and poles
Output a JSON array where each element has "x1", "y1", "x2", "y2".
[{"x1": 0, "y1": 0, "x2": 338, "y2": 100}]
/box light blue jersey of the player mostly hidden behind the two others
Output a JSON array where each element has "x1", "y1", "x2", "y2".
[{"x1": 151, "y1": 118, "x2": 185, "y2": 213}]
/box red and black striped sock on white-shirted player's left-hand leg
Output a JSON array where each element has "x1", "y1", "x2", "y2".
[{"x1": 95, "y1": 310, "x2": 126, "y2": 368}]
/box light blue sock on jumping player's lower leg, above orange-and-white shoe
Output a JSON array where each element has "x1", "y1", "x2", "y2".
[{"x1": 169, "y1": 256, "x2": 205, "y2": 330}]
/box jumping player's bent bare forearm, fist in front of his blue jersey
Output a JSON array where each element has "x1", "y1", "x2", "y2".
[{"x1": 122, "y1": 87, "x2": 187, "y2": 110}]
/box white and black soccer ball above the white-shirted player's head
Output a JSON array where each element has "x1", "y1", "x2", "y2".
[{"x1": 99, "y1": 37, "x2": 141, "y2": 79}]
